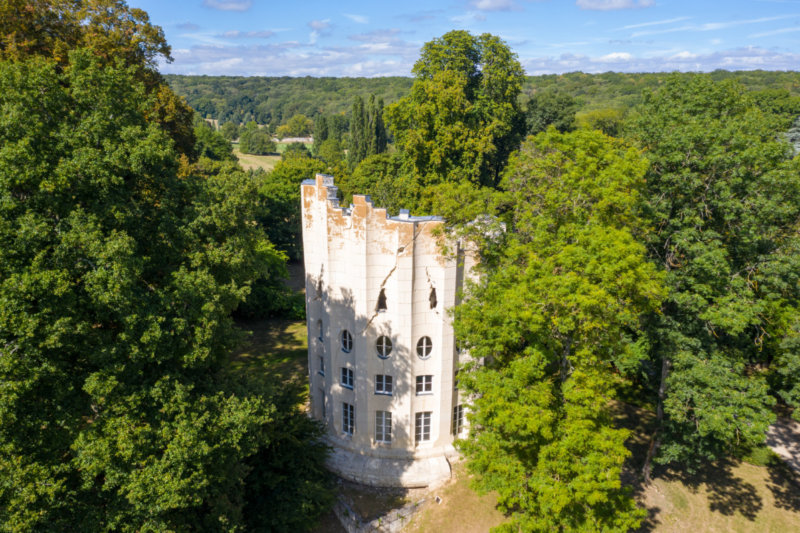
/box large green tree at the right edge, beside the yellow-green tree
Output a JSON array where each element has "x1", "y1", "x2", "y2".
[{"x1": 629, "y1": 75, "x2": 800, "y2": 478}]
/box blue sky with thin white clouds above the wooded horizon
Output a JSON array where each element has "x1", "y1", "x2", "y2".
[{"x1": 134, "y1": 0, "x2": 800, "y2": 77}]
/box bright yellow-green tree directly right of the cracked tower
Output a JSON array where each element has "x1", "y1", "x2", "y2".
[{"x1": 455, "y1": 128, "x2": 664, "y2": 531}]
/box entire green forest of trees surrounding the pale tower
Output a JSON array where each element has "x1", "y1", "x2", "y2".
[{"x1": 0, "y1": 0, "x2": 800, "y2": 532}]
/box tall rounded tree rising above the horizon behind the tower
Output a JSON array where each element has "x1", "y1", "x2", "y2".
[{"x1": 386, "y1": 31, "x2": 525, "y2": 186}]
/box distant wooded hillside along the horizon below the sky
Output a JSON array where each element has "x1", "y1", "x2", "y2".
[{"x1": 166, "y1": 70, "x2": 800, "y2": 130}]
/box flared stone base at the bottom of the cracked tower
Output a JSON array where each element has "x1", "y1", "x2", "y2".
[{"x1": 326, "y1": 438, "x2": 456, "y2": 488}]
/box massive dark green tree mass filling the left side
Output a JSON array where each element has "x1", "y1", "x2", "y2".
[{"x1": 0, "y1": 50, "x2": 322, "y2": 531}]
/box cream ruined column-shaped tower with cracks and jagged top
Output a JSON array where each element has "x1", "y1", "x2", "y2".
[{"x1": 301, "y1": 174, "x2": 474, "y2": 487}]
